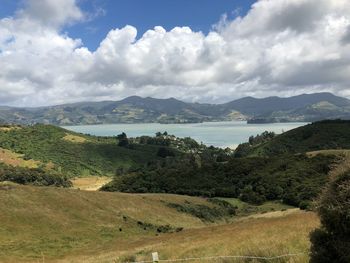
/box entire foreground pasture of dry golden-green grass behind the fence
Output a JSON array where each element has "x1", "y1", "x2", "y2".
[{"x1": 0, "y1": 184, "x2": 318, "y2": 262}]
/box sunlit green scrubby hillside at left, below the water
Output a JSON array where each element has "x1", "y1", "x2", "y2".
[{"x1": 0, "y1": 125, "x2": 173, "y2": 176}]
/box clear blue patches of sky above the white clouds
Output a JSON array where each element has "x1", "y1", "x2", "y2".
[{"x1": 0, "y1": 0, "x2": 255, "y2": 50}]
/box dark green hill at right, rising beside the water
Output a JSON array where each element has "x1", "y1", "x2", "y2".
[{"x1": 236, "y1": 120, "x2": 350, "y2": 157}]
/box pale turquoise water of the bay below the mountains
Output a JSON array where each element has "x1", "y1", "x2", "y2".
[{"x1": 64, "y1": 121, "x2": 306, "y2": 147}]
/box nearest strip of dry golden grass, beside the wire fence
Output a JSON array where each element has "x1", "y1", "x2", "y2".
[{"x1": 58, "y1": 211, "x2": 319, "y2": 263}]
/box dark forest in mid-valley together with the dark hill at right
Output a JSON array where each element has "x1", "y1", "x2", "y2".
[{"x1": 103, "y1": 120, "x2": 350, "y2": 207}]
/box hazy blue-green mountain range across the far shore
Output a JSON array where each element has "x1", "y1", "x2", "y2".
[{"x1": 0, "y1": 93, "x2": 350, "y2": 125}]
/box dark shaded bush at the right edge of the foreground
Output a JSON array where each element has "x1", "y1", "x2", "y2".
[{"x1": 310, "y1": 171, "x2": 350, "y2": 263}]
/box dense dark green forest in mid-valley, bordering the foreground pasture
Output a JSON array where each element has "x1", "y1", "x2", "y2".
[{"x1": 102, "y1": 155, "x2": 335, "y2": 207}]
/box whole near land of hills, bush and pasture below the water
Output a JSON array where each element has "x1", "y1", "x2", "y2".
[{"x1": 0, "y1": 120, "x2": 350, "y2": 263}]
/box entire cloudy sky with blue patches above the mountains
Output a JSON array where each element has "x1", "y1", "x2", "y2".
[{"x1": 0, "y1": 0, "x2": 350, "y2": 106}]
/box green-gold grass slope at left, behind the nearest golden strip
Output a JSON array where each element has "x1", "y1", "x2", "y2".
[{"x1": 0, "y1": 184, "x2": 220, "y2": 262}]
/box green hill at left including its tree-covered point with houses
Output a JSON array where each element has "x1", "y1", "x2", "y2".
[{"x1": 0, "y1": 124, "x2": 224, "y2": 182}]
